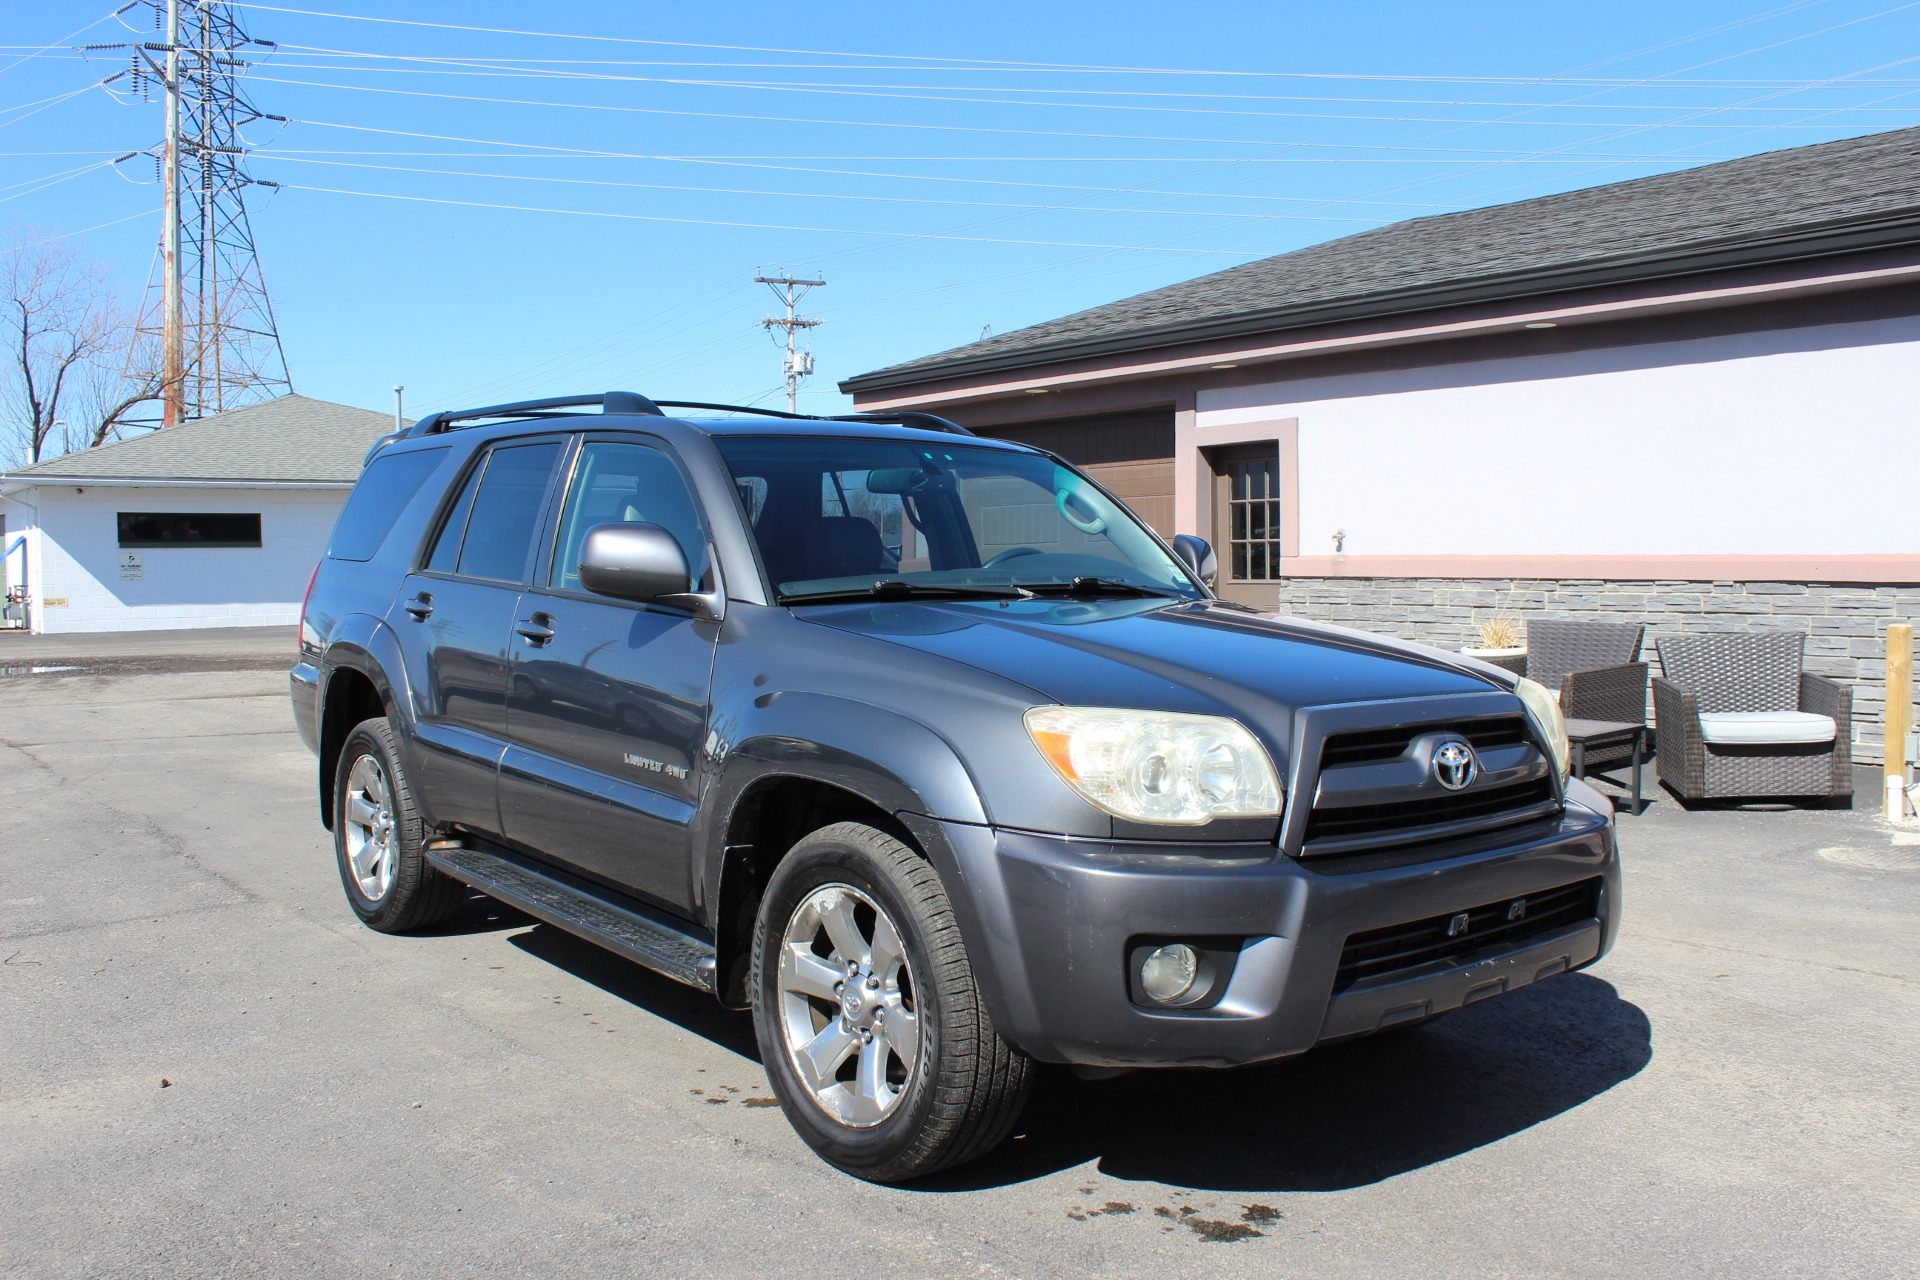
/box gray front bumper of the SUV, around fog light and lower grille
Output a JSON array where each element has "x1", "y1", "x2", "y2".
[{"x1": 910, "y1": 789, "x2": 1620, "y2": 1067}]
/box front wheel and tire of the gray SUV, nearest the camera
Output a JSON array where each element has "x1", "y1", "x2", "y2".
[{"x1": 751, "y1": 823, "x2": 1033, "y2": 1182}]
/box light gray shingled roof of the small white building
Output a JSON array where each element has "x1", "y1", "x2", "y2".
[{"x1": 4, "y1": 395, "x2": 394, "y2": 484}]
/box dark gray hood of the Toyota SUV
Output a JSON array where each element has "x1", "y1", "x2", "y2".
[{"x1": 797, "y1": 599, "x2": 1505, "y2": 747}]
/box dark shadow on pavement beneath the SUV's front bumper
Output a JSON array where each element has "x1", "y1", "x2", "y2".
[{"x1": 933, "y1": 973, "x2": 1653, "y2": 1192}]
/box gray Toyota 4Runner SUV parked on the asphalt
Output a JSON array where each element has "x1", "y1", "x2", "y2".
[{"x1": 292, "y1": 391, "x2": 1620, "y2": 1182}]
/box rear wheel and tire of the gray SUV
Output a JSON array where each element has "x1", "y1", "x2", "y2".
[{"x1": 334, "y1": 718, "x2": 467, "y2": 933}]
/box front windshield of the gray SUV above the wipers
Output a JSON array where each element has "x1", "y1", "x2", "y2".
[{"x1": 714, "y1": 436, "x2": 1204, "y2": 601}]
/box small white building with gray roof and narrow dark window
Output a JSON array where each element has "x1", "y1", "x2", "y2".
[{"x1": 0, "y1": 395, "x2": 394, "y2": 633}]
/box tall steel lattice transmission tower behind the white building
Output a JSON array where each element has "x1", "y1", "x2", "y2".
[{"x1": 86, "y1": 0, "x2": 294, "y2": 426}]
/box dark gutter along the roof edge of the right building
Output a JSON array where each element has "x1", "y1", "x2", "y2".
[{"x1": 839, "y1": 205, "x2": 1920, "y2": 395}]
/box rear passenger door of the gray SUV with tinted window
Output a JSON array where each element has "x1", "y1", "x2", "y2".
[{"x1": 388, "y1": 438, "x2": 566, "y2": 835}]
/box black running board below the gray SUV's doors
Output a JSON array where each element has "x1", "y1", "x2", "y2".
[{"x1": 426, "y1": 848, "x2": 718, "y2": 992}]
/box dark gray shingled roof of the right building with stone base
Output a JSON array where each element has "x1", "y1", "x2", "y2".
[{"x1": 841, "y1": 129, "x2": 1920, "y2": 391}]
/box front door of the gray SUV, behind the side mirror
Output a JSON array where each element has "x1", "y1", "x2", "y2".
[{"x1": 499, "y1": 436, "x2": 718, "y2": 910}]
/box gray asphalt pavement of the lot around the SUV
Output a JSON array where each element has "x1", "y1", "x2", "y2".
[{"x1": 0, "y1": 660, "x2": 1920, "y2": 1280}]
